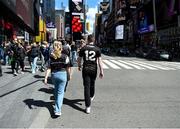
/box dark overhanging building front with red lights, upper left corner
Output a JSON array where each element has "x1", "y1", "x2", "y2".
[{"x1": 0, "y1": 0, "x2": 39, "y2": 42}]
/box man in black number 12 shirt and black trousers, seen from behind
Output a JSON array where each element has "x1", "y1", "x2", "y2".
[{"x1": 78, "y1": 35, "x2": 104, "y2": 114}]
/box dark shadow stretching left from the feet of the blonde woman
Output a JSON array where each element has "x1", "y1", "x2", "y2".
[{"x1": 23, "y1": 99, "x2": 57, "y2": 118}]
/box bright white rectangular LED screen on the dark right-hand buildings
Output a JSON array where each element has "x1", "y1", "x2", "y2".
[{"x1": 115, "y1": 25, "x2": 124, "y2": 40}]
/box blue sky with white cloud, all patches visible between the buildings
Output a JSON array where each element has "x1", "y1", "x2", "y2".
[{"x1": 55, "y1": 0, "x2": 102, "y2": 33}]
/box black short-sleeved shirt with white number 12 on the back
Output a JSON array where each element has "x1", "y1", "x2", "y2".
[{"x1": 79, "y1": 44, "x2": 101, "y2": 73}]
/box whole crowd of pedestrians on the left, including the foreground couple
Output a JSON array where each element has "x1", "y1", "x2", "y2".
[{"x1": 0, "y1": 35, "x2": 104, "y2": 116}]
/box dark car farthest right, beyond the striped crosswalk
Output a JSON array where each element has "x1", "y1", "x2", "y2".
[{"x1": 146, "y1": 49, "x2": 172, "y2": 61}]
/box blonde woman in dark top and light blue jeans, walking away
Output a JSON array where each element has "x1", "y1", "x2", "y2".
[{"x1": 44, "y1": 41, "x2": 70, "y2": 116}]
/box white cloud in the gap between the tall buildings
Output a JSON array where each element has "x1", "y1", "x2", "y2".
[{"x1": 86, "y1": 6, "x2": 98, "y2": 33}]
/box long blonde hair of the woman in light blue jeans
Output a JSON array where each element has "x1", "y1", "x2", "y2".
[{"x1": 51, "y1": 41, "x2": 62, "y2": 59}]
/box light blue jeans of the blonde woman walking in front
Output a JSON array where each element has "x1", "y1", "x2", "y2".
[{"x1": 51, "y1": 71, "x2": 67, "y2": 113}]
